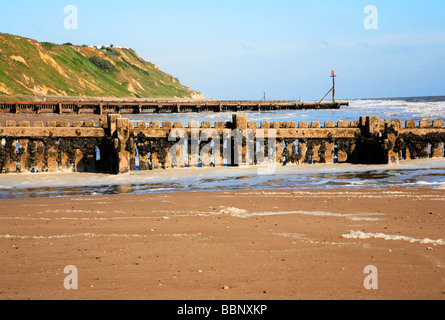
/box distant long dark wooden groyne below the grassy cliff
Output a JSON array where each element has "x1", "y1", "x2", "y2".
[{"x1": 0, "y1": 99, "x2": 349, "y2": 115}]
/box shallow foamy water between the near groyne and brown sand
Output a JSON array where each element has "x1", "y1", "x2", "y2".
[{"x1": 0, "y1": 158, "x2": 445, "y2": 199}]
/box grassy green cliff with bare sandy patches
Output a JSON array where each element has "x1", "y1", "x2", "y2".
[{"x1": 0, "y1": 33, "x2": 203, "y2": 98}]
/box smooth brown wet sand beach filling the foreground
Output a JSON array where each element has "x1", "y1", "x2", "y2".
[{"x1": 0, "y1": 188, "x2": 445, "y2": 300}]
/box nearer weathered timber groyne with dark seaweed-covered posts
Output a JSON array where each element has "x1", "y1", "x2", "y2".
[{"x1": 0, "y1": 114, "x2": 445, "y2": 173}]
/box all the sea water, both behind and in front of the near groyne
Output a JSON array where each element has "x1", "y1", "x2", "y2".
[{"x1": 0, "y1": 97, "x2": 445, "y2": 200}]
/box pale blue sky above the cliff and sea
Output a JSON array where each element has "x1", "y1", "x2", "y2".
[{"x1": 0, "y1": 0, "x2": 445, "y2": 100}]
